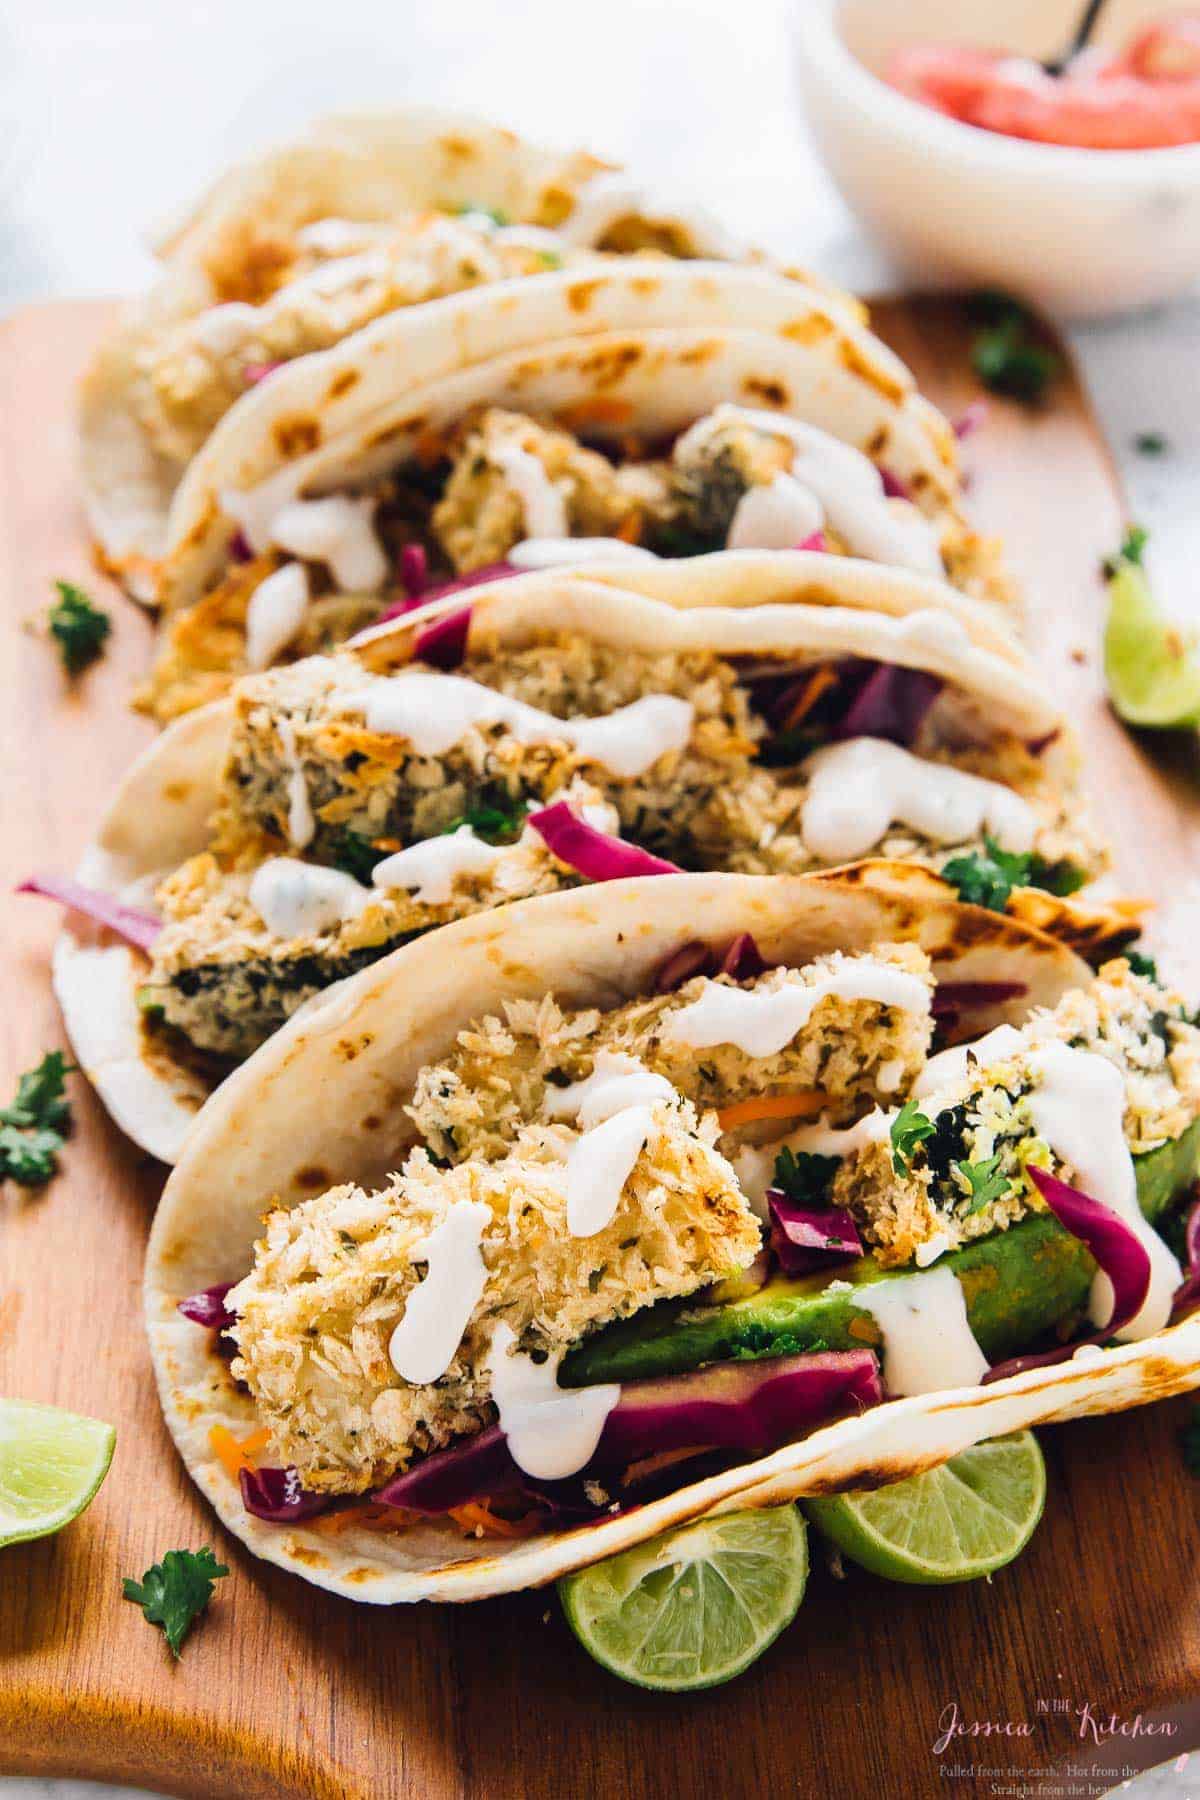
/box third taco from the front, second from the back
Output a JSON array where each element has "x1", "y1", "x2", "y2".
[{"x1": 140, "y1": 261, "x2": 1007, "y2": 722}]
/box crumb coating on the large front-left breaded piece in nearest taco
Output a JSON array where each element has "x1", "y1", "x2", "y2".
[{"x1": 228, "y1": 1100, "x2": 759, "y2": 1494}]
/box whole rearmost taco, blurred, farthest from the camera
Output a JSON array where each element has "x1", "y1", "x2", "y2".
[{"x1": 81, "y1": 108, "x2": 858, "y2": 599}]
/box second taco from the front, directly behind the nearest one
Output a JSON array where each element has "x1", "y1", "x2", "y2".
[{"x1": 25, "y1": 553, "x2": 1137, "y2": 1161}]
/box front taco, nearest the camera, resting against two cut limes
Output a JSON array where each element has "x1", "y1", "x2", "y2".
[{"x1": 146, "y1": 864, "x2": 1200, "y2": 1602}]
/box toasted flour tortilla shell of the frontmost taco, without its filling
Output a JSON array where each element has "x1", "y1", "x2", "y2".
[{"x1": 146, "y1": 864, "x2": 1200, "y2": 1604}]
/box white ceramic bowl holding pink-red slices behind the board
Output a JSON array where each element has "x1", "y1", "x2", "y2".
[{"x1": 793, "y1": 0, "x2": 1200, "y2": 319}]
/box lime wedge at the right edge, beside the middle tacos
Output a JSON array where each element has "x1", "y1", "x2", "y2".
[{"x1": 1105, "y1": 558, "x2": 1200, "y2": 727}]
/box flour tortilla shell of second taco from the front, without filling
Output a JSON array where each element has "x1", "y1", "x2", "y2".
[{"x1": 54, "y1": 551, "x2": 1135, "y2": 1163}]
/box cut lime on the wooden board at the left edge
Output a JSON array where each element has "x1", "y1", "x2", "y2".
[{"x1": 0, "y1": 1400, "x2": 117, "y2": 1550}]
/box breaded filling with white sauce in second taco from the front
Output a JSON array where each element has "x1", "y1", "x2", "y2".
[{"x1": 142, "y1": 617, "x2": 1105, "y2": 1058}]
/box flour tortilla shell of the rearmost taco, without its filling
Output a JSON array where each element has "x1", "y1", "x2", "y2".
[{"x1": 81, "y1": 106, "x2": 860, "y2": 601}]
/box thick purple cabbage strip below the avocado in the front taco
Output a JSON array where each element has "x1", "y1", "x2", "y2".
[{"x1": 376, "y1": 1350, "x2": 883, "y2": 1514}]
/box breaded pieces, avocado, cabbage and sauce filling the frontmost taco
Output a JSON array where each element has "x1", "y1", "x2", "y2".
[{"x1": 182, "y1": 936, "x2": 1200, "y2": 1535}]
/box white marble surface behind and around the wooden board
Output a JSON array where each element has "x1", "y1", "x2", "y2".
[{"x1": 0, "y1": 0, "x2": 1200, "y2": 1800}]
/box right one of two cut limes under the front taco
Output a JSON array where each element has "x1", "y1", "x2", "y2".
[{"x1": 802, "y1": 1431, "x2": 1045, "y2": 1584}]
